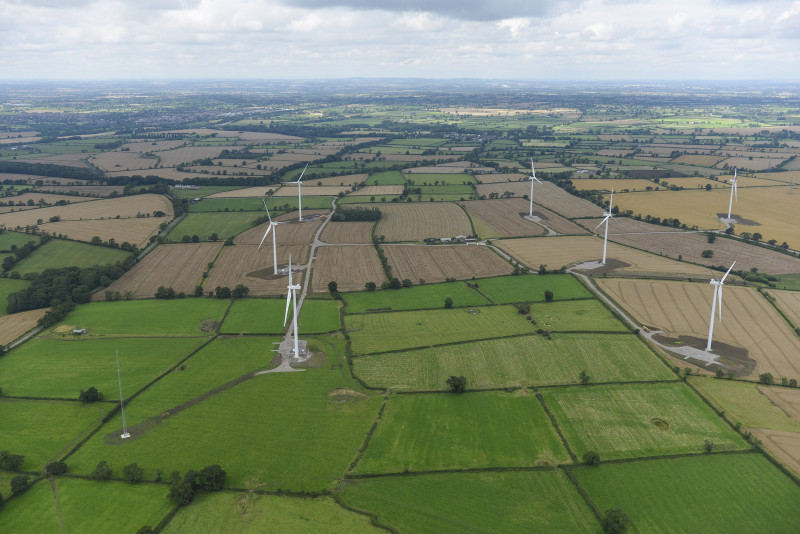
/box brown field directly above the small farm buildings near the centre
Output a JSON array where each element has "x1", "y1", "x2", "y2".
[{"x1": 375, "y1": 203, "x2": 472, "y2": 242}]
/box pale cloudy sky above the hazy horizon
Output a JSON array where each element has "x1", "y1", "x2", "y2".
[{"x1": 0, "y1": 0, "x2": 800, "y2": 81}]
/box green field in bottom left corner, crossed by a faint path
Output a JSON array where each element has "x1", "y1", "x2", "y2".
[{"x1": 3, "y1": 478, "x2": 172, "y2": 533}]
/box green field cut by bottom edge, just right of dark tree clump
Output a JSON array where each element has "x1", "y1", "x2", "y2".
[{"x1": 162, "y1": 493, "x2": 383, "y2": 534}]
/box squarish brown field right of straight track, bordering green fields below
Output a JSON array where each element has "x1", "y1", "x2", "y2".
[{"x1": 311, "y1": 246, "x2": 386, "y2": 293}]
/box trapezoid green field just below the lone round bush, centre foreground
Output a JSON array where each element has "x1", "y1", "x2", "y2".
[{"x1": 355, "y1": 392, "x2": 569, "y2": 473}]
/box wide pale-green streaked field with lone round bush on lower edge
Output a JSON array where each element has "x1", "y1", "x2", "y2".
[{"x1": 353, "y1": 334, "x2": 675, "y2": 391}]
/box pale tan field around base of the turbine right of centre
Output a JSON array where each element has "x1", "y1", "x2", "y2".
[{"x1": 494, "y1": 236, "x2": 708, "y2": 278}]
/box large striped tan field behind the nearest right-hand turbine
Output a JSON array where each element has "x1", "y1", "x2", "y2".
[{"x1": 595, "y1": 278, "x2": 800, "y2": 378}]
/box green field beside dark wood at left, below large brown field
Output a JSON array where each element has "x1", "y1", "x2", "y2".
[{"x1": 54, "y1": 298, "x2": 230, "y2": 336}]
